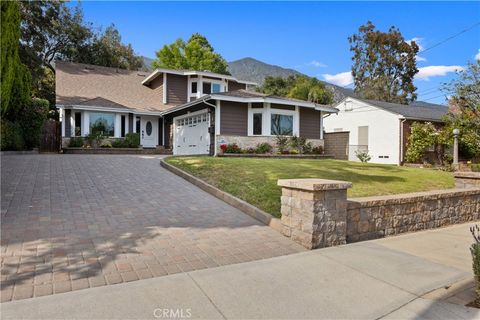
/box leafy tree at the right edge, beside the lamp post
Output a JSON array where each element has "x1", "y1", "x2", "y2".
[{"x1": 443, "y1": 61, "x2": 480, "y2": 158}]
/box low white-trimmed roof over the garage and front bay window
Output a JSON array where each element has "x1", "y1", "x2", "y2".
[{"x1": 164, "y1": 89, "x2": 338, "y2": 114}]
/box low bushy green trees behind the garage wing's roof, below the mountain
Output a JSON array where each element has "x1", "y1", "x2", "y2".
[{"x1": 257, "y1": 75, "x2": 333, "y2": 104}]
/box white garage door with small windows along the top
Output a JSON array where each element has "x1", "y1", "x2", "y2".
[{"x1": 173, "y1": 112, "x2": 210, "y2": 155}]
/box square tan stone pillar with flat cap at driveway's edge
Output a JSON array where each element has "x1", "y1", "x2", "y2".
[{"x1": 278, "y1": 179, "x2": 352, "y2": 249}]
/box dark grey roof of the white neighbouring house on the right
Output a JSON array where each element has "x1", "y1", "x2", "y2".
[{"x1": 344, "y1": 97, "x2": 448, "y2": 122}]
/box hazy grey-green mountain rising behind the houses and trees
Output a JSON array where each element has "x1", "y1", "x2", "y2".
[{"x1": 228, "y1": 58, "x2": 355, "y2": 102}]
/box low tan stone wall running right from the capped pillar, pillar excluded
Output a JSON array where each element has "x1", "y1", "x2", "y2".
[{"x1": 347, "y1": 189, "x2": 480, "y2": 242}]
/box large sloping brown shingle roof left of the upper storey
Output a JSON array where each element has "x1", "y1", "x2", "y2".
[{"x1": 55, "y1": 61, "x2": 171, "y2": 112}]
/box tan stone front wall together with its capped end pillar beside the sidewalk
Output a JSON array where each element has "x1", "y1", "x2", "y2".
[{"x1": 278, "y1": 176, "x2": 480, "y2": 249}]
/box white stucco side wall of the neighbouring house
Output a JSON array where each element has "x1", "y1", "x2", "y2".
[{"x1": 323, "y1": 99, "x2": 400, "y2": 164}]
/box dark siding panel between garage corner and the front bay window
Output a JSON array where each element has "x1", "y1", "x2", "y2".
[{"x1": 220, "y1": 101, "x2": 248, "y2": 136}]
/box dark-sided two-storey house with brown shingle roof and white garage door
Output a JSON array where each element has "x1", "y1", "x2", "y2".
[{"x1": 56, "y1": 62, "x2": 337, "y2": 155}]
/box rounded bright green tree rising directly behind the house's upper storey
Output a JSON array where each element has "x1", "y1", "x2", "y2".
[{"x1": 152, "y1": 33, "x2": 230, "y2": 74}]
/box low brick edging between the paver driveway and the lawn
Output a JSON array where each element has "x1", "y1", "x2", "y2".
[{"x1": 160, "y1": 157, "x2": 282, "y2": 232}]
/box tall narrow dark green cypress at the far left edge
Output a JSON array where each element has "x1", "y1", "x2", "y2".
[{"x1": 0, "y1": 1, "x2": 31, "y2": 115}]
